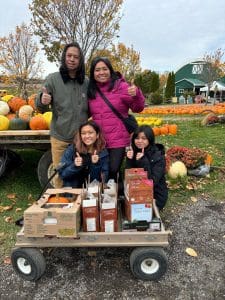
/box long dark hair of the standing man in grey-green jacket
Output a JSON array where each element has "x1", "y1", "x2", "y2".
[{"x1": 59, "y1": 42, "x2": 85, "y2": 84}]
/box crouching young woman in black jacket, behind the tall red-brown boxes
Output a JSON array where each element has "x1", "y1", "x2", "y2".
[{"x1": 126, "y1": 125, "x2": 168, "y2": 209}]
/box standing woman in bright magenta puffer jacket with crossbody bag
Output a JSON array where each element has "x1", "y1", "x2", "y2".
[{"x1": 88, "y1": 57, "x2": 144, "y2": 181}]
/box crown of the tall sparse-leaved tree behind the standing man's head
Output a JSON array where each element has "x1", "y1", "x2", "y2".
[{"x1": 29, "y1": 0, "x2": 123, "y2": 62}]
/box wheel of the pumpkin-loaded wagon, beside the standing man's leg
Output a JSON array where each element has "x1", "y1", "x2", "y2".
[{"x1": 37, "y1": 150, "x2": 54, "y2": 188}]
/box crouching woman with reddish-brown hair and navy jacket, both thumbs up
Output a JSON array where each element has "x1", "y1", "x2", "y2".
[{"x1": 59, "y1": 121, "x2": 109, "y2": 188}]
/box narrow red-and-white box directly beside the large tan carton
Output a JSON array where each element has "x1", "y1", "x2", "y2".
[{"x1": 82, "y1": 198, "x2": 99, "y2": 232}]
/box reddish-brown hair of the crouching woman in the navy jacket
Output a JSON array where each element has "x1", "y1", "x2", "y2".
[{"x1": 74, "y1": 120, "x2": 105, "y2": 153}]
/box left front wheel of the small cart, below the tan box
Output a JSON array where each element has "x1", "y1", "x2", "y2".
[{"x1": 11, "y1": 248, "x2": 46, "y2": 281}]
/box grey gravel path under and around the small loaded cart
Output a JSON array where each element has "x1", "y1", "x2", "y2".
[{"x1": 0, "y1": 199, "x2": 225, "y2": 300}]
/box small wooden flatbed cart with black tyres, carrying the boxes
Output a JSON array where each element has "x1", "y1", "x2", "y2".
[{"x1": 11, "y1": 197, "x2": 171, "y2": 281}]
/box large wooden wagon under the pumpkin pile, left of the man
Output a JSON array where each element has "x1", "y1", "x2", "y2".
[{"x1": 0, "y1": 130, "x2": 53, "y2": 186}]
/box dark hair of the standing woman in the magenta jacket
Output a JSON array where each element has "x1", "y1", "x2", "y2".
[{"x1": 87, "y1": 56, "x2": 119, "y2": 99}]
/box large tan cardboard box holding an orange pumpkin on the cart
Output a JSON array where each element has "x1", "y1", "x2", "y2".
[{"x1": 24, "y1": 189, "x2": 81, "y2": 238}]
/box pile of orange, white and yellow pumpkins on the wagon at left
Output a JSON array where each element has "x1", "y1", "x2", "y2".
[{"x1": 0, "y1": 94, "x2": 52, "y2": 131}]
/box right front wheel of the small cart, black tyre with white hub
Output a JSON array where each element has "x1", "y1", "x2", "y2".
[{"x1": 130, "y1": 247, "x2": 167, "y2": 280}]
